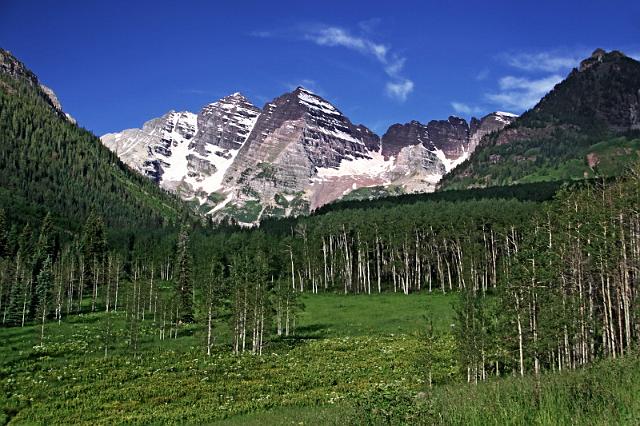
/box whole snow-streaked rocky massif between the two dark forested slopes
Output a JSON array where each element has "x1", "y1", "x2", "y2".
[{"x1": 101, "y1": 87, "x2": 515, "y2": 223}]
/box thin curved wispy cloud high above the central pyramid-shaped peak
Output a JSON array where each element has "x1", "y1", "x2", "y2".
[{"x1": 303, "y1": 26, "x2": 414, "y2": 102}]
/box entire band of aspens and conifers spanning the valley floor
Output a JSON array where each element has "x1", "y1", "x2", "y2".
[{"x1": 0, "y1": 163, "x2": 640, "y2": 381}]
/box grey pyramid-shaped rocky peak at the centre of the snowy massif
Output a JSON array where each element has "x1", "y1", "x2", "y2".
[{"x1": 218, "y1": 88, "x2": 379, "y2": 218}]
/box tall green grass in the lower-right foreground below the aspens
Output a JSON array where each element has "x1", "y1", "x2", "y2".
[{"x1": 418, "y1": 355, "x2": 640, "y2": 425}]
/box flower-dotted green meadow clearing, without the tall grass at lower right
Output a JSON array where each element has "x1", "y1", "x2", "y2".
[{"x1": 0, "y1": 294, "x2": 456, "y2": 424}]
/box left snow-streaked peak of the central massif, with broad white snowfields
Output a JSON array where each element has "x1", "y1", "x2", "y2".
[{"x1": 101, "y1": 93, "x2": 260, "y2": 204}]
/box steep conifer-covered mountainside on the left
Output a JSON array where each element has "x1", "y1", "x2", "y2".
[{"x1": 0, "y1": 49, "x2": 185, "y2": 230}]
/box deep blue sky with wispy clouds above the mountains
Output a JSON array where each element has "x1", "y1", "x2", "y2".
[{"x1": 0, "y1": 0, "x2": 640, "y2": 135}]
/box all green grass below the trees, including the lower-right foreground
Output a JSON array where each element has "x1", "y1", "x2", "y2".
[{"x1": 0, "y1": 294, "x2": 640, "y2": 425}]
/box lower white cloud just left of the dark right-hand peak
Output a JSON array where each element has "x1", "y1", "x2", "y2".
[{"x1": 485, "y1": 74, "x2": 562, "y2": 111}]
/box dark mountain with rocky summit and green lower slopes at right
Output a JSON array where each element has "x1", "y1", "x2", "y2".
[{"x1": 440, "y1": 49, "x2": 640, "y2": 189}]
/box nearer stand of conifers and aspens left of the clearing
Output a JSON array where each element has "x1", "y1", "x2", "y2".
[{"x1": 0, "y1": 209, "x2": 301, "y2": 355}]
